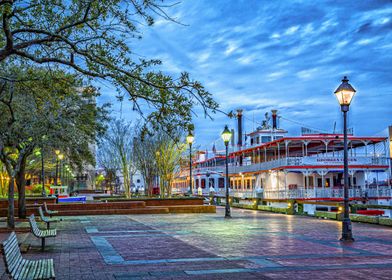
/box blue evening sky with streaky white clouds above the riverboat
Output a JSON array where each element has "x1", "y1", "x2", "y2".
[{"x1": 96, "y1": 0, "x2": 392, "y2": 148}]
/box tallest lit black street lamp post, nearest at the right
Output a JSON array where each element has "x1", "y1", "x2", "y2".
[{"x1": 334, "y1": 76, "x2": 356, "y2": 241}]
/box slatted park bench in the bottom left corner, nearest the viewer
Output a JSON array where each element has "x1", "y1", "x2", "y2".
[{"x1": 1, "y1": 232, "x2": 56, "y2": 280}]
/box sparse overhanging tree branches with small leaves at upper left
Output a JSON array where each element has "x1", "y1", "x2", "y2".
[{"x1": 0, "y1": 0, "x2": 218, "y2": 134}]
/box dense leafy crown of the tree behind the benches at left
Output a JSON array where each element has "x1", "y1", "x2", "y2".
[{"x1": 0, "y1": 65, "x2": 107, "y2": 173}]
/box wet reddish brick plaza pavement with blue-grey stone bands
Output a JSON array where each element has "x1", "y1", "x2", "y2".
[{"x1": 0, "y1": 208, "x2": 392, "y2": 280}]
